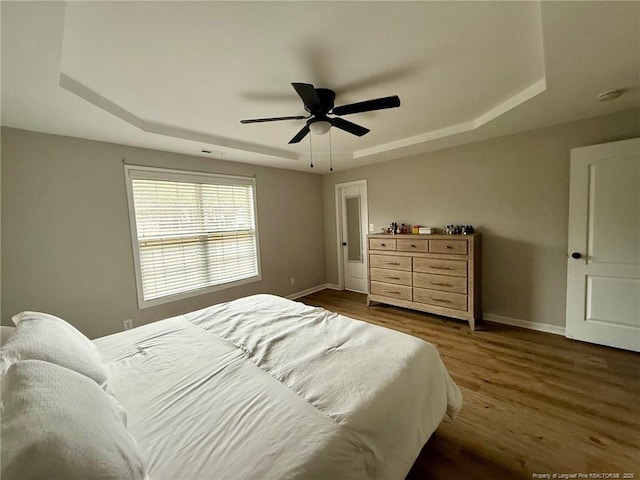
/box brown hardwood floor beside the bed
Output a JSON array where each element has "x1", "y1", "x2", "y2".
[{"x1": 298, "y1": 290, "x2": 640, "y2": 480}]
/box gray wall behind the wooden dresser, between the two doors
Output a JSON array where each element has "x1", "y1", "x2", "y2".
[{"x1": 323, "y1": 110, "x2": 640, "y2": 330}]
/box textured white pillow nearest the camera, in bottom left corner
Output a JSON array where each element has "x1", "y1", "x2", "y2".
[{"x1": 0, "y1": 360, "x2": 147, "y2": 480}]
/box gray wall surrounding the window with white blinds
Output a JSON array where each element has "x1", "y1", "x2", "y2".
[{"x1": 1, "y1": 128, "x2": 325, "y2": 338}]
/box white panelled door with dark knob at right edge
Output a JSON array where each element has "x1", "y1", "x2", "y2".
[{"x1": 566, "y1": 139, "x2": 640, "y2": 352}]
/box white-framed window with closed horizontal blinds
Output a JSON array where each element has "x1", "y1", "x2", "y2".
[{"x1": 125, "y1": 165, "x2": 260, "y2": 307}]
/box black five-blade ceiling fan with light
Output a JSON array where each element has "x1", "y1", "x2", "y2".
[{"x1": 240, "y1": 83, "x2": 400, "y2": 143}]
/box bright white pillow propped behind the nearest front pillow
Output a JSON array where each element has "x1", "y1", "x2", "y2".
[{"x1": 0, "y1": 312, "x2": 107, "y2": 387}]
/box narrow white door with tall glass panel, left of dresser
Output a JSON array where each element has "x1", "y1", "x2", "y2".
[{"x1": 336, "y1": 180, "x2": 368, "y2": 293}]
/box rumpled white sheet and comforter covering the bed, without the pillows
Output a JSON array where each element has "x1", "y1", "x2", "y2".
[{"x1": 94, "y1": 295, "x2": 462, "y2": 480}]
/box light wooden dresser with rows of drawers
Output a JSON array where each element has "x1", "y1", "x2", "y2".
[{"x1": 367, "y1": 233, "x2": 482, "y2": 330}]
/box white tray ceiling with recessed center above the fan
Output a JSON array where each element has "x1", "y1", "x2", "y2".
[{"x1": 0, "y1": 1, "x2": 640, "y2": 173}]
